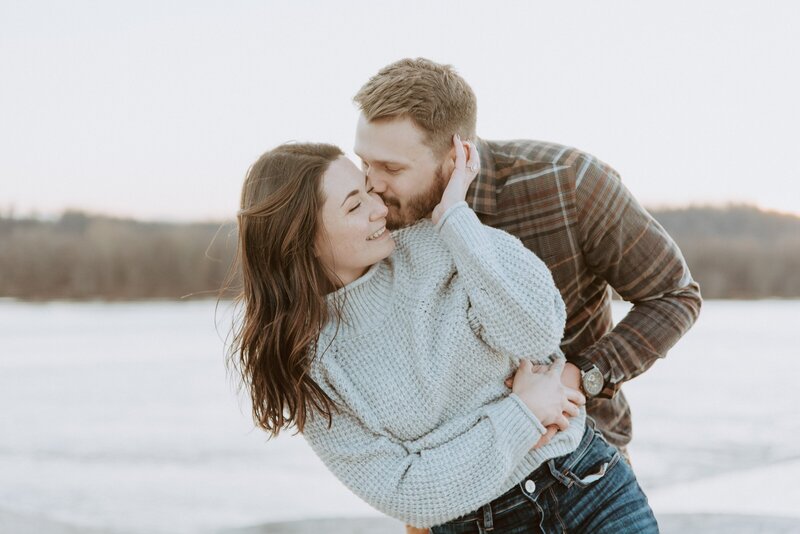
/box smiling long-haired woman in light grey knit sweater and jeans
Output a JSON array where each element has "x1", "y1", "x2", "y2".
[{"x1": 227, "y1": 138, "x2": 657, "y2": 533}]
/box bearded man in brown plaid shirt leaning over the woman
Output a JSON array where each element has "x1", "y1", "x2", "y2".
[{"x1": 354, "y1": 58, "x2": 702, "y2": 534}]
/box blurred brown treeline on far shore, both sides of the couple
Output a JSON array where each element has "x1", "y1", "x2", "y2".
[{"x1": 0, "y1": 206, "x2": 800, "y2": 299}]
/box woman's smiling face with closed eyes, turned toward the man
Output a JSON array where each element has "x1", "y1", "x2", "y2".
[{"x1": 315, "y1": 156, "x2": 394, "y2": 285}]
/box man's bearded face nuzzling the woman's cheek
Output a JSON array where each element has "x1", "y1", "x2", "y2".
[{"x1": 355, "y1": 114, "x2": 452, "y2": 230}]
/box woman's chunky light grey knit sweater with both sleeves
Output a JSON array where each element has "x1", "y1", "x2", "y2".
[{"x1": 304, "y1": 202, "x2": 585, "y2": 527}]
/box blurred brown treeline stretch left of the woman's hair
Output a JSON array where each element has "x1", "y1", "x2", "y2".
[{"x1": 0, "y1": 211, "x2": 236, "y2": 300}]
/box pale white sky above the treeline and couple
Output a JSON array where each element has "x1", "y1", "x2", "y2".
[{"x1": 0, "y1": 0, "x2": 800, "y2": 220}]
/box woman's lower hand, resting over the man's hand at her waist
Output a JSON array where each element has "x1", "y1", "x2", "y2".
[{"x1": 511, "y1": 359, "x2": 586, "y2": 434}]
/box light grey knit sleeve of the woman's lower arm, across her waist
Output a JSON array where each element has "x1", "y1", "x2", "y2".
[{"x1": 303, "y1": 393, "x2": 546, "y2": 528}]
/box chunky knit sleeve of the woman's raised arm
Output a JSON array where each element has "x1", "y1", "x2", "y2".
[{"x1": 437, "y1": 202, "x2": 567, "y2": 360}]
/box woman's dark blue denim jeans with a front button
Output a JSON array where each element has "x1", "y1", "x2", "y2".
[{"x1": 431, "y1": 420, "x2": 658, "y2": 534}]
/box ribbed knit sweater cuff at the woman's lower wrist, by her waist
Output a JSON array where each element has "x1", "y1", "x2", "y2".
[{"x1": 486, "y1": 393, "x2": 547, "y2": 463}]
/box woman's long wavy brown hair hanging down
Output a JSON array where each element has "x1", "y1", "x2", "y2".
[{"x1": 229, "y1": 144, "x2": 343, "y2": 437}]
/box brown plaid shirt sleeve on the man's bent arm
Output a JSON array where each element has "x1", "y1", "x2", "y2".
[{"x1": 575, "y1": 155, "x2": 702, "y2": 384}]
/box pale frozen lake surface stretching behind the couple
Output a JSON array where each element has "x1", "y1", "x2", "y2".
[{"x1": 0, "y1": 301, "x2": 800, "y2": 532}]
